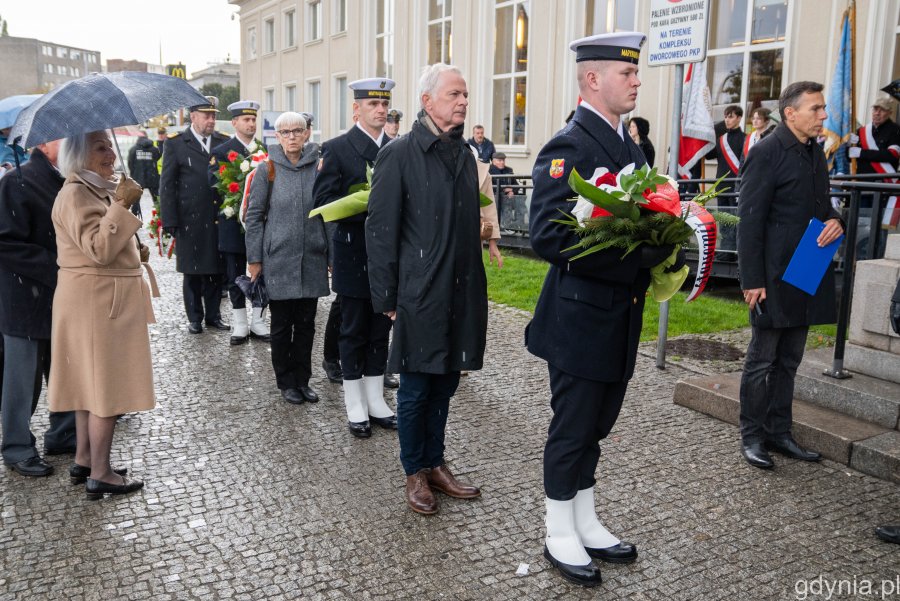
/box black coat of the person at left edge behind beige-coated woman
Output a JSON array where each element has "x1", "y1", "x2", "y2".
[{"x1": 0, "y1": 148, "x2": 65, "y2": 340}]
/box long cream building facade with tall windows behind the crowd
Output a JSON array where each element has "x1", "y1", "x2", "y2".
[{"x1": 229, "y1": 0, "x2": 900, "y2": 173}]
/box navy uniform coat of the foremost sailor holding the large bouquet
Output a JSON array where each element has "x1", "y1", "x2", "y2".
[{"x1": 525, "y1": 106, "x2": 650, "y2": 382}]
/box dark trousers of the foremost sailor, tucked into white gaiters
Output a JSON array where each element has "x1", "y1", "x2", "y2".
[{"x1": 544, "y1": 365, "x2": 628, "y2": 501}]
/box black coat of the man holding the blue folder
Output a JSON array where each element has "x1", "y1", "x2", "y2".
[{"x1": 737, "y1": 124, "x2": 840, "y2": 328}]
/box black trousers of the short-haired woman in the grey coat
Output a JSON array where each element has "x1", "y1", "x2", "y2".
[{"x1": 269, "y1": 298, "x2": 318, "y2": 390}]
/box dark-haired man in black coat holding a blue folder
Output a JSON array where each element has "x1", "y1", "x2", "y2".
[{"x1": 738, "y1": 81, "x2": 843, "y2": 468}]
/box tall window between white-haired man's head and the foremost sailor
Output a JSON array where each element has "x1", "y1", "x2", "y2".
[{"x1": 488, "y1": 0, "x2": 531, "y2": 145}]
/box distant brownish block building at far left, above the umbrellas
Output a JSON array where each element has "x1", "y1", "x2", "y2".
[{"x1": 0, "y1": 36, "x2": 101, "y2": 97}]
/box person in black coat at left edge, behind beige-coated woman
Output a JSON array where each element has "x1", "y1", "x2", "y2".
[{"x1": 0, "y1": 140, "x2": 75, "y2": 476}]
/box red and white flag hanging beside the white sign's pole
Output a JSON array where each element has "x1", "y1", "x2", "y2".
[{"x1": 678, "y1": 61, "x2": 716, "y2": 179}]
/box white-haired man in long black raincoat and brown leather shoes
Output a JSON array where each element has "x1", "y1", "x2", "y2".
[{"x1": 366, "y1": 64, "x2": 487, "y2": 514}]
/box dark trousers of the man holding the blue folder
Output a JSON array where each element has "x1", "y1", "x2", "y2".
[{"x1": 740, "y1": 326, "x2": 809, "y2": 444}]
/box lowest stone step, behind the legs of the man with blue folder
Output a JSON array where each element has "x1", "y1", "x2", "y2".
[{"x1": 674, "y1": 373, "x2": 900, "y2": 483}]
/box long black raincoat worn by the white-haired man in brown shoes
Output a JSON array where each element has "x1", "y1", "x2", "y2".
[{"x1": 364, "y1": 116, "x2": 487, "y2": 374}]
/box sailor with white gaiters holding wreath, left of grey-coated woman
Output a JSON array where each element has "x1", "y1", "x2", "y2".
[{"x1": 209, "y1": 100, "x2": 269, "y2": 346}]
